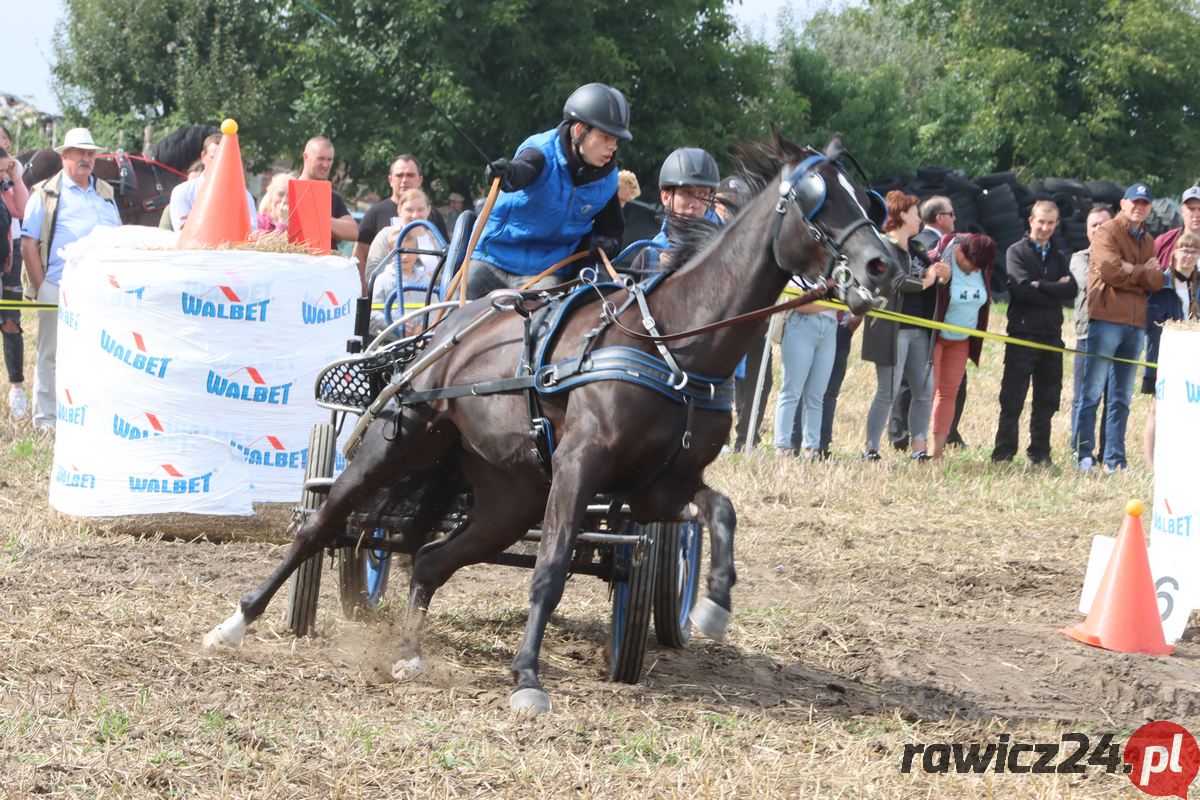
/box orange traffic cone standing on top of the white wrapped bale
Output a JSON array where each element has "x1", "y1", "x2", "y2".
[{"x1": 176, "y1": 120, "x2": 250, "y2": 249}]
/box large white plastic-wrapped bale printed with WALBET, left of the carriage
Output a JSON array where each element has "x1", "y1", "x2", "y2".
[{"x1": 50, "y1": 228, "x2": 359, "y2": 516}]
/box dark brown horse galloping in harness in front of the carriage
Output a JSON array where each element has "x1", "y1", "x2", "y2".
[{"x1": 204, "y1": 134, "x2": 896, "y2": 712}]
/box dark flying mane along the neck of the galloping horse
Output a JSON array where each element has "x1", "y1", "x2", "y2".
[{"x1": 668, "y1": 128, "x2": 814, "y2": 266}]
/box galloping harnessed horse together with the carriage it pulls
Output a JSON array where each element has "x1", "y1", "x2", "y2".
[{"x1": 204, "y1": 132, "x2": 899, "y2": 714}]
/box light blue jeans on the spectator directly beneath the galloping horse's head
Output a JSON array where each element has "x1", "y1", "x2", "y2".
[{"x1": 775, "y1": 312, "x2": 838, "y2": 450}]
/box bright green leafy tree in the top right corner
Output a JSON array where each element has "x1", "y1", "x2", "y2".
[{"x1": 904, "y1": 0, "x2": 1200, "y2": 191}]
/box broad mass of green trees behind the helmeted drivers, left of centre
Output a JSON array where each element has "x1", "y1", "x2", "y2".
[{"x1": 56, "y1": 0, "x2": 806, "y2": 192}]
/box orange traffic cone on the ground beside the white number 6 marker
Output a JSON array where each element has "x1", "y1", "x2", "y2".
[{"x1": 1062, "y1": 500, "x2": 1175, "y2": 656}]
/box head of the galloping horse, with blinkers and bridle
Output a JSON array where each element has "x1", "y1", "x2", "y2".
[{"x1": 772, "y1": 131, "x2": 899, "y2": 313}]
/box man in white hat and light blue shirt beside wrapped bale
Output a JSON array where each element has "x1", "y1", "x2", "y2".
[{"x1": 20, "y1": 128, "x2": 121, "y2": 431}]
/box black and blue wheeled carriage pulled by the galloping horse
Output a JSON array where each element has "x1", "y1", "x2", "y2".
[{"x1": 284, "y1": 211, "x2": 703, "y2": 684}]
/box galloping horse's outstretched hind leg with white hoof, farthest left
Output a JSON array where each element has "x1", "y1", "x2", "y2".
[{"x1": 203, "y1": 413, "x2": 454, "y2": 650}]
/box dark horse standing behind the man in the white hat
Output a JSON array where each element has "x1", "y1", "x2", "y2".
[{"x1": 17, "y1": 150, "x2": 187, "y2": 227}]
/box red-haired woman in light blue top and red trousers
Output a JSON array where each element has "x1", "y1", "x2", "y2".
[{"x1": 929, "y1": 234, "x2": 996, "y2": 458}]
